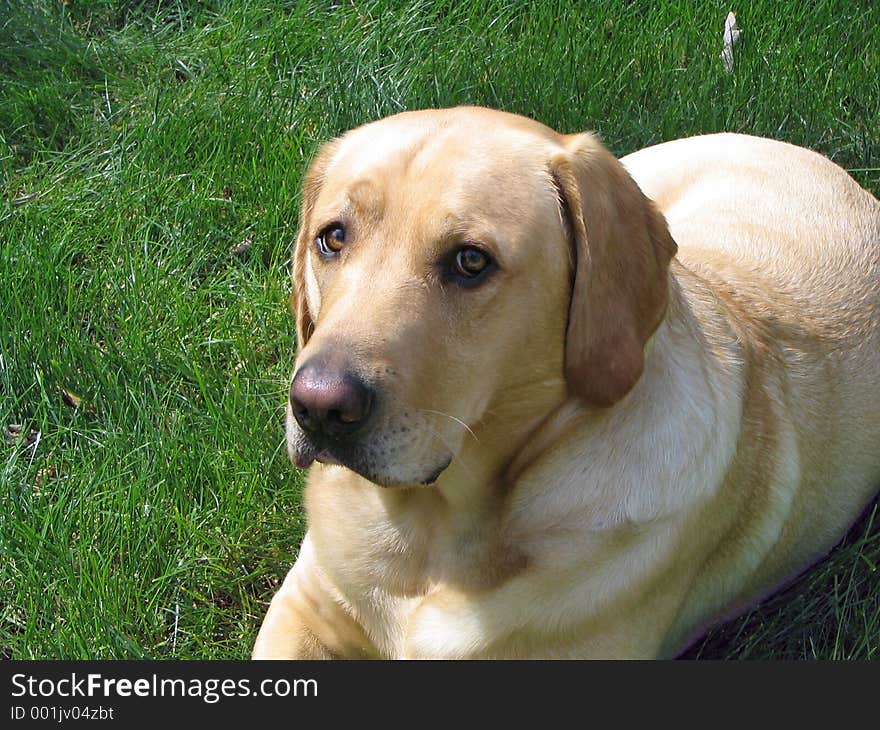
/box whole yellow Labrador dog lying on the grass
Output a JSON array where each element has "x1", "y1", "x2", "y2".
[{"x1": 253, "y1": 108, "x2": 880, "y2": 658}]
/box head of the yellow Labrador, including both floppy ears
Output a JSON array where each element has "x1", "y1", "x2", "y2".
[{"x1": 287, "y1": 107, "x2": 675, "y2": 486}]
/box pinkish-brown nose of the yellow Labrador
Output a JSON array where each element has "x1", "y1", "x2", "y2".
[{"x1": 290, "y1": 363, "x2": 373, "y2": 437}]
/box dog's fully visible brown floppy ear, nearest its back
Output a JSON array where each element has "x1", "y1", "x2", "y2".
[{"x1": 551, "y1": 134, "x2": 677, "y2": 407}]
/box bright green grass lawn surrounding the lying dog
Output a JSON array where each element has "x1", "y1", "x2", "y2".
[{"x1": 0, "y1": 0, "x2": 880, "y2": 659}]
